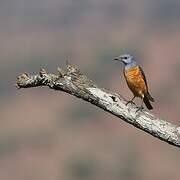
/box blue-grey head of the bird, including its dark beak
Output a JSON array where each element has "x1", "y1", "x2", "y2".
[{"x1": 114, "y1": 54, "x2": 137, "y2": 67}]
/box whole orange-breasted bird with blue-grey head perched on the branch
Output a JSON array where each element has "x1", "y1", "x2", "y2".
[{"x1": 114, "y1": 54, "x2": 154, "y2": 110}]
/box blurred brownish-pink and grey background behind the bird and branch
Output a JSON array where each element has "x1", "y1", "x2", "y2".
[{"x1": 0, "y1": 0, "x2": 180, "y2": 180}]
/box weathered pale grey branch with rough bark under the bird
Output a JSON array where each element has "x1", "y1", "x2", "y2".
[{"x1": 16, "y1": 64, "x2": 180, "y2": 147}]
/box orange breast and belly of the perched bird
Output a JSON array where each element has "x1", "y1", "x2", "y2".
[{"x1": 124, "y1": 67, "x2": 147, "y2": 97}]
